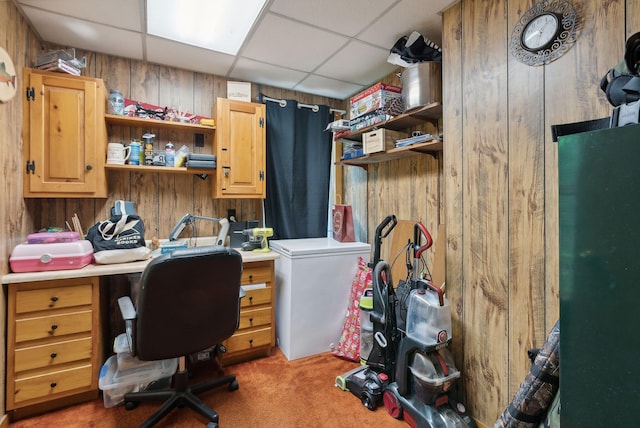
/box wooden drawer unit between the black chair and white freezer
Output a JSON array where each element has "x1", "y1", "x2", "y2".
[{"x1": 221, "y1": 260, "x2": 275, "y2": 363}]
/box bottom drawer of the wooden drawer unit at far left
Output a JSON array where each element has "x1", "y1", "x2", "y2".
[{"x1": 13, "y1": 364, "x2": 94, "y2": 403}]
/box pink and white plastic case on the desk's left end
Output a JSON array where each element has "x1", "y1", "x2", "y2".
[{"x1": 9, "y1": 239, "x2": 93, "y2": 272}]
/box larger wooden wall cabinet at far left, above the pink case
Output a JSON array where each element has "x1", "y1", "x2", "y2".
[{"x1": 23, "y1": 68, "x2": 107, "y2": 198}]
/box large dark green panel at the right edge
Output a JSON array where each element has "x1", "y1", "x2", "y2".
[{"x1": 558, "y1": 125, "x2": 640, "y2": 428}]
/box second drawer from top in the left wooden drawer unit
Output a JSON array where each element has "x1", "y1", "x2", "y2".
[{"x1": 15, "y1": 310, "x2": 92, "y2": 343}]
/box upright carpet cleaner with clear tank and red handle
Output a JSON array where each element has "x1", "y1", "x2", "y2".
[{"x1": 383, "y1": 222, "x2": 476, "y2": 428}]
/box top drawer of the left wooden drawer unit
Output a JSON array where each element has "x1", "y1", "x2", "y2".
[{"x1": 16, "y1": 284, "x2": 92, "y2": 314}]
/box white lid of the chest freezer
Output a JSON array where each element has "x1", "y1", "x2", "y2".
[{"x1": 269, "y1": 238, "x2": 371, "y2": 257}]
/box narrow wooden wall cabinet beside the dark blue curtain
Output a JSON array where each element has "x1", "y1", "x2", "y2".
[{"x1": 213, "y1": 98, "x2": 266, "y2": 198}]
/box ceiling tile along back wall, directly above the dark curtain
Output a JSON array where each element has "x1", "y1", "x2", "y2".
[{"x1": 229, "y1": 58, "x2": 307, "y2": 89}]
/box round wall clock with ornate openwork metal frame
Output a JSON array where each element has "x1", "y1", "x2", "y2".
[{"x1": 509, "y1": 0, "x2": 577, "y2": 65}]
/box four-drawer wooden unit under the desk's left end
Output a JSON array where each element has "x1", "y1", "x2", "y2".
[{"x1": 6, "y1": 277, "x2": 103, "y2": 413}]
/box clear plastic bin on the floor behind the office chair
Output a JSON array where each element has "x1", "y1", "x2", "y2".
[{"x1": 98, "y1": 355, "x2": 178, "y2": 408}]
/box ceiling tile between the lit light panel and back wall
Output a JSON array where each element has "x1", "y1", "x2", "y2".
[{"x1": 146, "y1": 36, "x2": 234, "y2": 76}]
